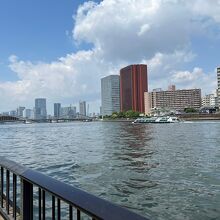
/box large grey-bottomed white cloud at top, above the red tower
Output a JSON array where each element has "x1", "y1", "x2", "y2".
[{"x1": 73, "y1": 0, "x2": 191, "y2": 61}]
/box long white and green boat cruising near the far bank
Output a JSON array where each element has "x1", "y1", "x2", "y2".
[{"x1": 132, "y1": 116, "x2": 180, "y2": 124}]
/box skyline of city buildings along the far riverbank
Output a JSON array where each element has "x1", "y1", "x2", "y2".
[{"x1": 0, "y1": 64, "x2": 220, "y2": 116}]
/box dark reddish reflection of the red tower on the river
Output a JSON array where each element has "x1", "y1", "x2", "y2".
[{"x1": 112, "y1": 123, "x2": 158, "y2": 172}]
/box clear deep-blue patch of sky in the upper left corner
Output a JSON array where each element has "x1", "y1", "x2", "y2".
[{"x1": 0, "y1": 0, "x2": 83, "y2": 81}]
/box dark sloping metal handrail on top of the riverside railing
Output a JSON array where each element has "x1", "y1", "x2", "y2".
[{"x1": 0, "y1": 157, "x2": 150, "y2": 220}]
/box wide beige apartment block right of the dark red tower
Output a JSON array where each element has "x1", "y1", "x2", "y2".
[{"x1": 144, "y1": 86, "x2": 201, "y2": 114}]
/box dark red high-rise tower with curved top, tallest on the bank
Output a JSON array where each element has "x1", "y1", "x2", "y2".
[{"x1": 120, "y1": 64, "x2": 148, "y2": 113}]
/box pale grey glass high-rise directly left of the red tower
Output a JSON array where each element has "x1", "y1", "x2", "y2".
[{"x1": 101, "y1": 75, "x2": 120, "y2": 115}]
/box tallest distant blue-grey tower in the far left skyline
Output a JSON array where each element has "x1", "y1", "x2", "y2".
[{"x1": 34, "y1": 98, "x2": 47, "y2": 120}]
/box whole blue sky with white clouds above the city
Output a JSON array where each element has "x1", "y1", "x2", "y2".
[{"x1": 0, "y1": 0, "x2": 220, "y2": 113}]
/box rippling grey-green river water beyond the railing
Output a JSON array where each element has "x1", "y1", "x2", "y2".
[{"x1": 0, "y1": 121, "x2": 220, "y2": 220}]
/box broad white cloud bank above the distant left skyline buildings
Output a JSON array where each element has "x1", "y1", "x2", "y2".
[{"x1": 0, "y1": 50, "x2": 123, "y2": 110}]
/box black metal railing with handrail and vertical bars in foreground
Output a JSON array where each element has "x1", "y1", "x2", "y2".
[{"x1": 0, "y1": 157, "x2": 147, "y2": 220}]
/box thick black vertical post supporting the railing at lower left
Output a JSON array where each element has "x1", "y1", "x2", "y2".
[{"x1": 21, "y1": 179, "x2": 33, "y2": 220}]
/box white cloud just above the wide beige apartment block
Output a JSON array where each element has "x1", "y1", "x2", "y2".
[{"x1": 139, "y1": 51, "x2": 217, "y2": 94}]
